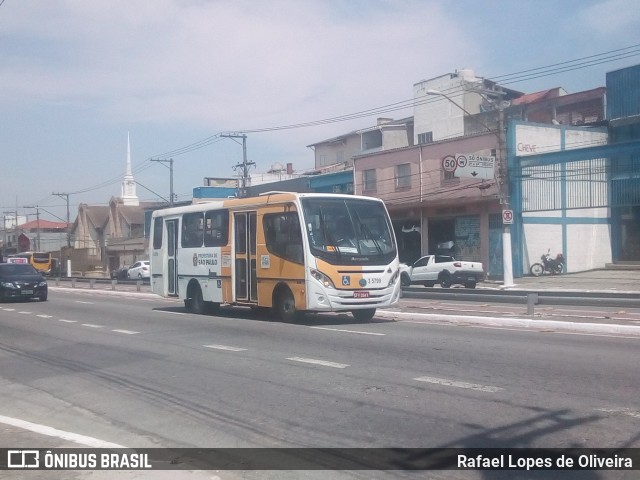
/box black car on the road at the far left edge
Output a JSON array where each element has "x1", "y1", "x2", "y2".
[{"x1": 0, "y1": 263, "x2": 48, "y2": 302}]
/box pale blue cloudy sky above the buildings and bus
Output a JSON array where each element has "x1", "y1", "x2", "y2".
[{"x1": 0, "y1": 0, "x2": 640, "y2": 220}]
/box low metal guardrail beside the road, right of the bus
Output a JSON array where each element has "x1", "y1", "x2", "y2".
[{"x1": 402, "y1": 287, "x2": 640, "y2": 315}]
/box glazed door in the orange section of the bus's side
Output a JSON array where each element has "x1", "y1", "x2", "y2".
[{"x1": 233, "y1": 212, "x2": 258, "y2": 303}]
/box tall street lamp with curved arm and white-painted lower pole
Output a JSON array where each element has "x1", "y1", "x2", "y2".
[{"x1": 426, "y1": 90, "x2": 513, "y2": 287}]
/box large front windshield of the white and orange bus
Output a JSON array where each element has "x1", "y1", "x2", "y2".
[{"x1": 302, "y1": 198, "x2": 396, "y2": 265}]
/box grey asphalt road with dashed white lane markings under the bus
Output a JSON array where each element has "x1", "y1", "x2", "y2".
[{"x1": 0, "y1": 290, "x2": 640, "y2": 478}]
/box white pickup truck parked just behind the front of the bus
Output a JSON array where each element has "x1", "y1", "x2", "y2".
[{"x1": 400, "y1": 255, "x2": 484, "y2": 288}]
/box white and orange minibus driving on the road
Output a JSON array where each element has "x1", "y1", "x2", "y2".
[{"x1": 149, "y1": 192, "x2": 400, "y2": 320}]
